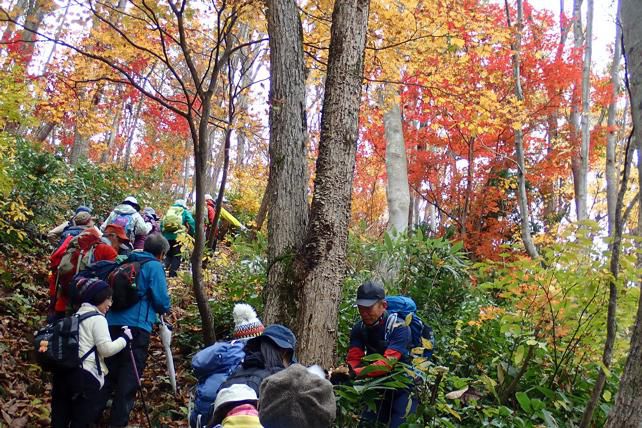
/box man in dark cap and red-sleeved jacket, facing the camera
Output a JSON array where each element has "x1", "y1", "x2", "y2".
[{"x1": 347, "y1": 280, "x2": 416, "y2": 428}]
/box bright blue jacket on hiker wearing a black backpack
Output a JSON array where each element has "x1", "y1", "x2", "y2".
[{"x1": 107, "y1": 251, "x2": 170, "y2": 333}]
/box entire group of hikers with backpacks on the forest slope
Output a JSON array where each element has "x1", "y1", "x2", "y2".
[{"x1": 35, "y1": 195, "x2": 430, "y2": 428}]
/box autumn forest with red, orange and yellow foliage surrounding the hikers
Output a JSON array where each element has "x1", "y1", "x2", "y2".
[{"x1": 0, "y1": 0, "x2": 642, "y2": 428}]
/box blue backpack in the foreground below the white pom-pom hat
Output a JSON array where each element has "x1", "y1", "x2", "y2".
[{"x1": 189, "y1": 341, "x2": 245, "y2": 428}]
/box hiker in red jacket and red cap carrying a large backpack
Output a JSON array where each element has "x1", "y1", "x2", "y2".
[{"x1": 48, "y1": 229, "x2": 118, "y2": 321}]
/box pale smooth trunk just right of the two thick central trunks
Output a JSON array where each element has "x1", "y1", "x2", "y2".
[{"x1": 383, "y1": 100, "x2": 410, "y2": 234}]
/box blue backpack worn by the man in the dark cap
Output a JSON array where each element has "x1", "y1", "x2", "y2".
[{"x1": 386, "y1": 296, "x2": 435, "y2": 358}]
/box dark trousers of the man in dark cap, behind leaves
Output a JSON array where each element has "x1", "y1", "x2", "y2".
[{"x1": 359, "y1": 389, "x2": 417, "y2": 428}]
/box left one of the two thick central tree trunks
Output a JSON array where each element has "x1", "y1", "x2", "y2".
[{"x1": 263, "y1": 0, "x2": 308, "y2": 327}]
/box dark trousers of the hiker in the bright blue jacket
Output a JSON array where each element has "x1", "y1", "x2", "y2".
[{"x1": 100, "y1": 326, "x2": 149, "y2": 427}]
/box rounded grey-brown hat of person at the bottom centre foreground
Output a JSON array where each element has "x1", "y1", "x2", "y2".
[{"x1": 259, "y1": 364, "x2": 337, "y2": 428}]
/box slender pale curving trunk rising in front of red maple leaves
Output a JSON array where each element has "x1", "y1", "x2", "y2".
[{"x1": 505, "y1": 0, "x2": 539, "y2": 258}]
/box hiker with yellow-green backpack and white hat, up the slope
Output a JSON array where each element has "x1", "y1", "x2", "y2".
[{"x1": 161, "y1": 199, "x2": 196, "y2": 278}]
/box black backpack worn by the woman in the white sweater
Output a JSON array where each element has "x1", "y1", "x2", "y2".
[{"x1": 34, "y1": 311, "x2": 102, "y2": 373}]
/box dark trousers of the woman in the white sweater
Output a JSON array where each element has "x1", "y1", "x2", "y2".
[{"x1": 51, "y1": 368, "x2": 100, "y2": 428}]
